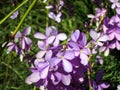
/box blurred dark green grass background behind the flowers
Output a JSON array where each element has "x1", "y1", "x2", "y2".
[{"x1": 0, "y1": 0, "x2": 120, "y2": 90}]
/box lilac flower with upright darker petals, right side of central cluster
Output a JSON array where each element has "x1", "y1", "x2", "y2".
[{"x1": 68, "y1": 30, "x2": 90, "y2": 65}]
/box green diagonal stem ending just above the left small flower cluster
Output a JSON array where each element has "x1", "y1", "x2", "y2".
[{"x1": 12, "y1": 0, "x2": 37, "y2": 38}]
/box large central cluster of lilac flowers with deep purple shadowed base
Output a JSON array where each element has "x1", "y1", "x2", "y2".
[{"x1": 26, "y1": 26, "x2": 90, "y2": 90}]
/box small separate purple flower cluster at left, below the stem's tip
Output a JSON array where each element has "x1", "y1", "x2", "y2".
[{"x1": 7, "y1": 27, "x2": 32, "y2": 61}]
